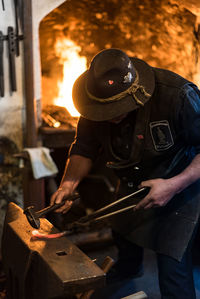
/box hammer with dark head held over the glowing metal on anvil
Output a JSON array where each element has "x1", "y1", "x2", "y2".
[{"x1": 24, "y1": 193, "x2": 80, "y2": 229}]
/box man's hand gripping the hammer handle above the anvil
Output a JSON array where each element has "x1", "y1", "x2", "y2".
[{"x1": 50, "y1": 186, "x2": 73, "y2": 214}]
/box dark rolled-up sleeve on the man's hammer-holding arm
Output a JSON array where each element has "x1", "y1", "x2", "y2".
[{"x1": 69, "y1": 117, "x2": 101, "y2": 160}]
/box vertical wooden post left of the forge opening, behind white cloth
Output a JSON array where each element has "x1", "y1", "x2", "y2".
[{"x1": 23, "y1": 0, "x2": 45, "y2": 210}]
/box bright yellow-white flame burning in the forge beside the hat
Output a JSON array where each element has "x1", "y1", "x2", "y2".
[{"x1": 54, "y1": 38, "x2": 87, "y2": 117}]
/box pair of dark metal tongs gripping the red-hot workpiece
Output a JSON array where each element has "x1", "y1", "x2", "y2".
[{"x1": 66, "y1": 187, "x2": 149, "y2": 233}]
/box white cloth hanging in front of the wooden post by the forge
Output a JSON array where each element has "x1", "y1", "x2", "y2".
[{"x1": 24, "y1": 147, "x2": 58, "y2": 179}]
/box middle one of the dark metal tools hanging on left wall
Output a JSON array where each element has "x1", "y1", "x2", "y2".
[{"x1": 8, "y1": 26, "x2": 17, "y2": 91}]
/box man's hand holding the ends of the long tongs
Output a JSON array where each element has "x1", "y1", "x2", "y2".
[{"x1": 134, "y1": 179, "x2": 177, "y2": 211}]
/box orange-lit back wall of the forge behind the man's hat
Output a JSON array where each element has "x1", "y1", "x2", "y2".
[{"x1": 40, "y1": 0, "x2": 200, "y2": 103}]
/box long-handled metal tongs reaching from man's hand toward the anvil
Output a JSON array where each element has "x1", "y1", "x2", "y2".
[{"x1": 69, "y1": 187, "x2": 149, "y2": 229}]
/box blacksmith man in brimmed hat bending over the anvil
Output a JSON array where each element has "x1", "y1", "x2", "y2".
[{"x1": 51, "y1": 49, "x2": 200, "y2": 299}]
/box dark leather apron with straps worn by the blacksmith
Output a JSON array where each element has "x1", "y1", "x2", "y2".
[{"x1": 104, "y1": 92, "x2": 200, "y2": 261}]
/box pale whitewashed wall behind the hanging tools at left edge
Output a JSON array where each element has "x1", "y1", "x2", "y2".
[{"x1": 0, "y1": 0, "x2": 25, "y2": 149}]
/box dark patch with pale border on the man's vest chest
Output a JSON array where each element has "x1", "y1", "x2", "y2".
[{"x1": 149, "y1": 120, "x2": 174, "y2": 151}]
